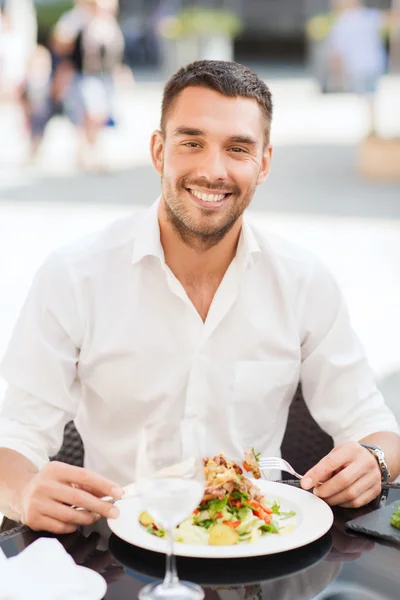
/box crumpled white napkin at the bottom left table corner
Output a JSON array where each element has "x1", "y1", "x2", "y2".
[{"x1": 0, "y1": 538, "x2": 104, "y2": 600}]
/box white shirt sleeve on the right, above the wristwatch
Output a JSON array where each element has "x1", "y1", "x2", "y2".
[{"x1": 301, "y1": 263, "x2": 399, "y2": 445}]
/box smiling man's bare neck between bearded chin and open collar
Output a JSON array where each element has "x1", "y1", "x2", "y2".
[{"x1": 158, "y1": 201, "x2": 242, "y2": 283}]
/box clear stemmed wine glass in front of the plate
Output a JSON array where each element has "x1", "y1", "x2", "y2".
[{"x1": 136, "y1": 420, "x2": 204, "y2": 600}]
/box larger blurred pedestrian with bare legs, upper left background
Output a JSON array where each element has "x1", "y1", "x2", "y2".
[{"x1": 28, "y1": 0, "x2": 124, "y2": 168}]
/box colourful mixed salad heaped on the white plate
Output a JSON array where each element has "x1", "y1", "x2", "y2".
[{"x1": 139, "y1": 450, "x2": 296, "y2": 546}]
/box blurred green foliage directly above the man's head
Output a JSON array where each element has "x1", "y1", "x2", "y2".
[{"x1": 160, "y1": 7, "x2": 243, "y2": 39}]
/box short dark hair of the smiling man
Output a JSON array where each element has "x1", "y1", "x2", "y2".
[{"x1": 161, "y1": 60, "x2": 273, "y2": 144}]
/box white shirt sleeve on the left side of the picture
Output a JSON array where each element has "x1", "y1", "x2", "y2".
[{"x1": 0, "y1": 254, "x2": 83, "y2": 469}]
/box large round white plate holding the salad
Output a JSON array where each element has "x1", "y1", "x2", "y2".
[{"x1": 108, "y1": 481, "x2": 333, "y2": 558}]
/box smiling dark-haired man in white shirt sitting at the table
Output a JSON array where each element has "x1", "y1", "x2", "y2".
[{"x1": 0, "y1": 61, "x2": 400, "y2": 533}]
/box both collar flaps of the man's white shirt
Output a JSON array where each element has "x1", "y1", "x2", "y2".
[{"x1": 132, "y1": 198, "x2": 261, "y2": 266}]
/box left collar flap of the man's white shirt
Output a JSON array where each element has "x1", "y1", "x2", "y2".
[{"x1": 132, "y1": 198, "x2": 165, "y2": 264}]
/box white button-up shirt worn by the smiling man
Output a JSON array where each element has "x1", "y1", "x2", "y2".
[{"x1": 0, "y1": 203, "x2": 398, "y2": 484}]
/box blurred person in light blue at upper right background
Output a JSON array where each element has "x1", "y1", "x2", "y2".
[{"x1": 327, "y1": 0, "x2": 389, "y2": 135}]
